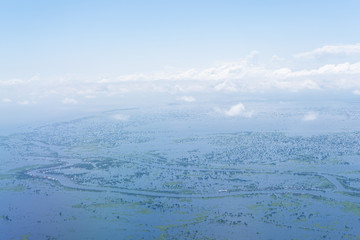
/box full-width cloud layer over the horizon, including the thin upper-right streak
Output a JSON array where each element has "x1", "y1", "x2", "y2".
[{"x1": 0, "y1": 43, "x2": 360, "y2": 105}]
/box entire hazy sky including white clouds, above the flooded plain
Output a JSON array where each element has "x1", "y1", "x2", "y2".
[{"x1": 0, "y1": 0, "x2": 360, "y2": 105}]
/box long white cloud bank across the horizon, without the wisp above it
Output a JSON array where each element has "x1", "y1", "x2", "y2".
[{"x1": 4, "y1": 60, "x2": 360, "y2": 99}]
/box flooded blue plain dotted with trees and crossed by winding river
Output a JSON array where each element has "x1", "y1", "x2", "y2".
[{"x1": 0, "y1": 101, "x2": 360, "y2": 239}]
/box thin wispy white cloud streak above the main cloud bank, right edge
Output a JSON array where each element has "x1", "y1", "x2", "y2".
[{"x1": 295, "y1": 43, "x2": 360, "y2": 58}]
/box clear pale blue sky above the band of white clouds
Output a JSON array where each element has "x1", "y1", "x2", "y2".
[{"x1": 0, "y1": 0, "x2": 360, "y2": 78}]
